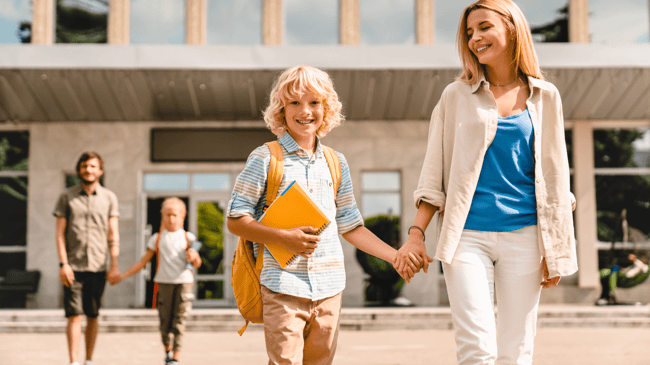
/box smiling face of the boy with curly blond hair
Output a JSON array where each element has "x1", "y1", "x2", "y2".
[{"x1": 284, "y1": 92, "x2": 324, "y2": 142}]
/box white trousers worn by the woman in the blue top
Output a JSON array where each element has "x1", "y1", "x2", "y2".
[{"x1": 442, "y1": 226, "x2": 542, "y2": 365}]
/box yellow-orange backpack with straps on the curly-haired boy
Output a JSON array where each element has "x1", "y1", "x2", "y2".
[{"x1": 232, "y1": 141, "x2": 341, "y2": 336}]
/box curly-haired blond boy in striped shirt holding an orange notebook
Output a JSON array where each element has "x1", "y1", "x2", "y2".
[{"x1": 228, "y1": 66, "x2": 418, "y2": 364}]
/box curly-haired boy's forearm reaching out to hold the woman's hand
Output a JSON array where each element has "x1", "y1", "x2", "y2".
[{"x1": 342, "y1": 226, "x2": 418, "y2": 282}]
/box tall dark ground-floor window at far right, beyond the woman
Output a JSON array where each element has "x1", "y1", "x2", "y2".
[{"x1": 593, "y1": 127, "x2": 650, "y2": 268}]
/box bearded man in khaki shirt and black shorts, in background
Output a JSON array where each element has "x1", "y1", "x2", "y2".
[{"x1": 53, "y1": 152, "x2": 120, "y2": 365}]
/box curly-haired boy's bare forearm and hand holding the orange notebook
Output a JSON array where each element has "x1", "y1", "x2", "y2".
[{"x1": 228, "y1": 215, "x2": 320, "y2": 258}]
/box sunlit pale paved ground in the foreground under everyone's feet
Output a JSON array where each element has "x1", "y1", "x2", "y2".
[{"x1": 0, "y1": 328, "x2": 650, "y2": 365}]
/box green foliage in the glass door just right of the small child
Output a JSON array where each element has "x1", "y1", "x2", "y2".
[{"x1": 198, "y1": 202, "x2": 224, "y2": 274}]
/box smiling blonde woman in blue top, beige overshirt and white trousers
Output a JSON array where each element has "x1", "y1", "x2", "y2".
[{"x1": 398, "y1": 0, "x2": 577, "y2": 365}]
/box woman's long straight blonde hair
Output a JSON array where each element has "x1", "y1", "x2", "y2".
[{"x1": 457, "y1": 0, "x2": 544, "y2": 84}]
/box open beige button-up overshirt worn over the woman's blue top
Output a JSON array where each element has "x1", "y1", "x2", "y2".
[{"x1": 413, "y1": 77, "x2": 578, "y2": 277}]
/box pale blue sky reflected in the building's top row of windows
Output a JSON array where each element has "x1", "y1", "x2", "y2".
[{"x1": 0, "y1": 0, "x2": 650, "y2": 45}]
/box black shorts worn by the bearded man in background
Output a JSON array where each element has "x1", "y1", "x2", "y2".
[{"x1": 63, "y1": 271, "x2": 106, "y2": 318}]
